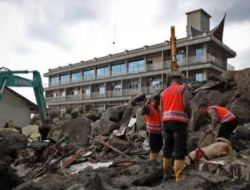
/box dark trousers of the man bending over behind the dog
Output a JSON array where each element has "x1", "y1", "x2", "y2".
[{"x1": 218, "y1": 118, "x2": 238, "y2": 140}]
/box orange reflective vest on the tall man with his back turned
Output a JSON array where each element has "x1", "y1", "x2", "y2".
[{"x1": 161, "y1": 84, "x2": 187, "y2": 123}]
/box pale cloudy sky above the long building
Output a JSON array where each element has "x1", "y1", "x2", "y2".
[{"x1": 0, "y1": 0, "x2": 250, "y2": 102}]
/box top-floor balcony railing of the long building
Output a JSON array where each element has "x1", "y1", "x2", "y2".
[{"x1": 45, "y1": 54, "x2": 227, "y2": 87}]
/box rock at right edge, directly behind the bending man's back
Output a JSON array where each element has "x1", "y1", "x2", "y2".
[{"x1": 231, "y1": 105, "x2": 250, "y2": 123}]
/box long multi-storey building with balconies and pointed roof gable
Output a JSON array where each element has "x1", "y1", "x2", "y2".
[{"x1": 44, "y1": 9, "x2": 236, "y2": 111}]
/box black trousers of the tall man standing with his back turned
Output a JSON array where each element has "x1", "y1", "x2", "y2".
[{"x1": 163, "y1": 121, "x2": 188, "y2": 160}]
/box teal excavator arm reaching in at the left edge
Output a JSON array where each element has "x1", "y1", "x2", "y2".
[{"x1": 0, "y1": 68, "x2": 49, "y2": 126}]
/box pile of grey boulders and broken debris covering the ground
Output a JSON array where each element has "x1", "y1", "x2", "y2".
[{"x1": 0, "y1": 69, "x2": 250, "y2": 190}]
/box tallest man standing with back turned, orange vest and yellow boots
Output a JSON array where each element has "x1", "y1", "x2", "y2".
[{"x1": 161, "y1": 76, "x2": 192, "y2": 182}]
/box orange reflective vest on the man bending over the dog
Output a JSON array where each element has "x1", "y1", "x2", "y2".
[{"x1": 208, "y1": 106, "x2": 236, "y2": 123}]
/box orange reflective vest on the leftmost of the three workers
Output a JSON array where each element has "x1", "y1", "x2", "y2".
[{"x1": 146, "y1": 105, "x2": 162, "y2": 133}]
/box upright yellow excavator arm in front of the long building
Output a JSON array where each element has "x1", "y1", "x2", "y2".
[{"x1": 166, "y1": 26, "x2": 191, "y2": 86}]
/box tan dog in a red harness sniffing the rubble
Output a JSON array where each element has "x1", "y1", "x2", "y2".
[{"x1": 185, "y1": 137, "x2": 233, "y2": 165}]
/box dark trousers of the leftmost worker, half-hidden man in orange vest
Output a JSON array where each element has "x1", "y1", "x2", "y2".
[{"x1": 147, "y1": 132, "x2": 163, "y2": 153}]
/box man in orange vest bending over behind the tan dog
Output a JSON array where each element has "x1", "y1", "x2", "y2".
[{"x1": 199, "y1": 104, "x2": 238, "y2": 140}]
